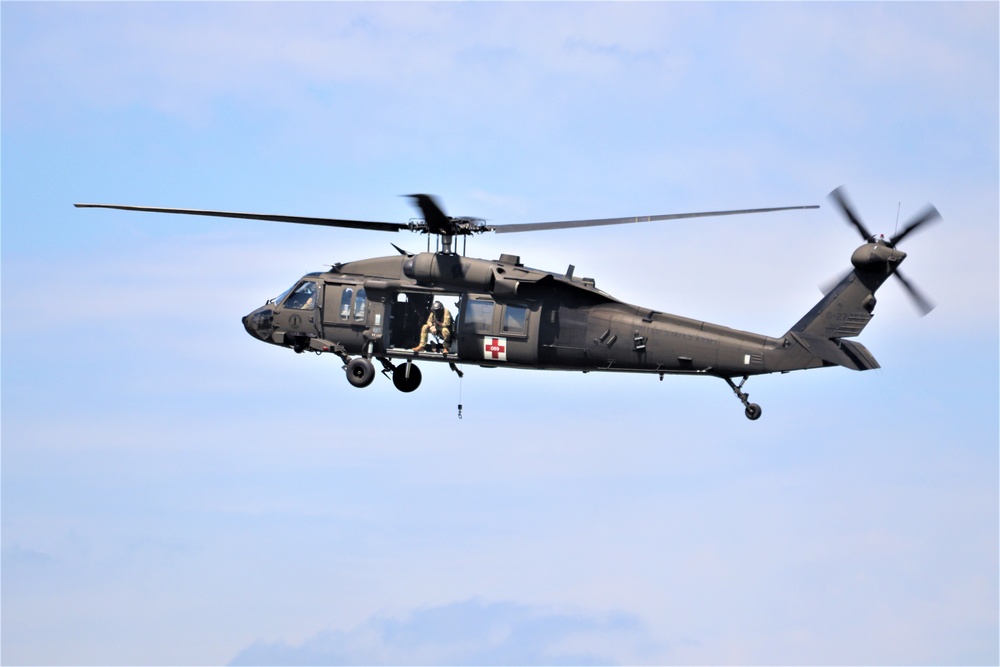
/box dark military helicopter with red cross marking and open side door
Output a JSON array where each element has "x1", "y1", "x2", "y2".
[{"x1": 76, "y1": 188, "x2": 940, "y2": 420}]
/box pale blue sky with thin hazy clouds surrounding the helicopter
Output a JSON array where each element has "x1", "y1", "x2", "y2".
[{"x1": 0, "y1": 2, "x2": 1000, "y2": 665}]
